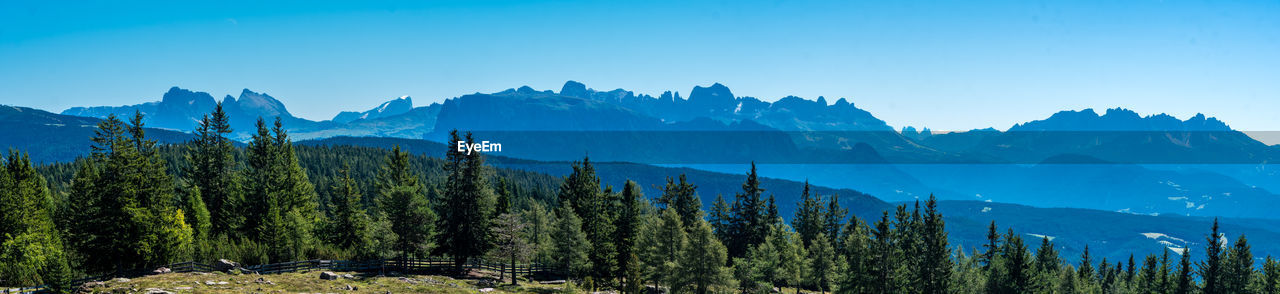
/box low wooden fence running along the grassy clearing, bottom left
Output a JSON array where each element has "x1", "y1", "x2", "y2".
[{"x1": 0, "y1": 257, "x2": 554, "y2": 293}]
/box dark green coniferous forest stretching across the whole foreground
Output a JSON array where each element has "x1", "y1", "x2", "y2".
[{"x1": 0, "y1": 105, "x2": 1280, "y2": 294}]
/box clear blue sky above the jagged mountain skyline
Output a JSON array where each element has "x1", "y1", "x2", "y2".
[{"x1": 0, "y1": 0, "x2": 1280, "y2": 135}]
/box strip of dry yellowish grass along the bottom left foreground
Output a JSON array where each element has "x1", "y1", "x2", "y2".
[{"x1": 83, "y1": 271, "x2": 576, "y2": 294}]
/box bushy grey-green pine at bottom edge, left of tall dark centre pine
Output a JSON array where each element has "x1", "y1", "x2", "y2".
[{"x1": 678, "y1": 220, "x2": 731, "y2": 294}]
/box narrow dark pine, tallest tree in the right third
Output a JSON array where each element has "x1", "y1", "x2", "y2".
[{"x1": 921, "y1": 194, "x2": 952, "y2": 293}]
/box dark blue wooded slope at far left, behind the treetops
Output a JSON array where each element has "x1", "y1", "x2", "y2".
[{"x1": 0, "y1": 105, "x2": 191, "y2": 162}]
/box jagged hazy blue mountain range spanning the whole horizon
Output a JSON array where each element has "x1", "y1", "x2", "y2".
[{"x1": 0, "y1": 81, "x2": 1280, "y2": 217}]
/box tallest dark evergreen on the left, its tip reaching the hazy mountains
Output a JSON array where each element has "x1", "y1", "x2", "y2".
[{"x1": 186, "y1": 102, "x2": 248, "y2": 236}]
